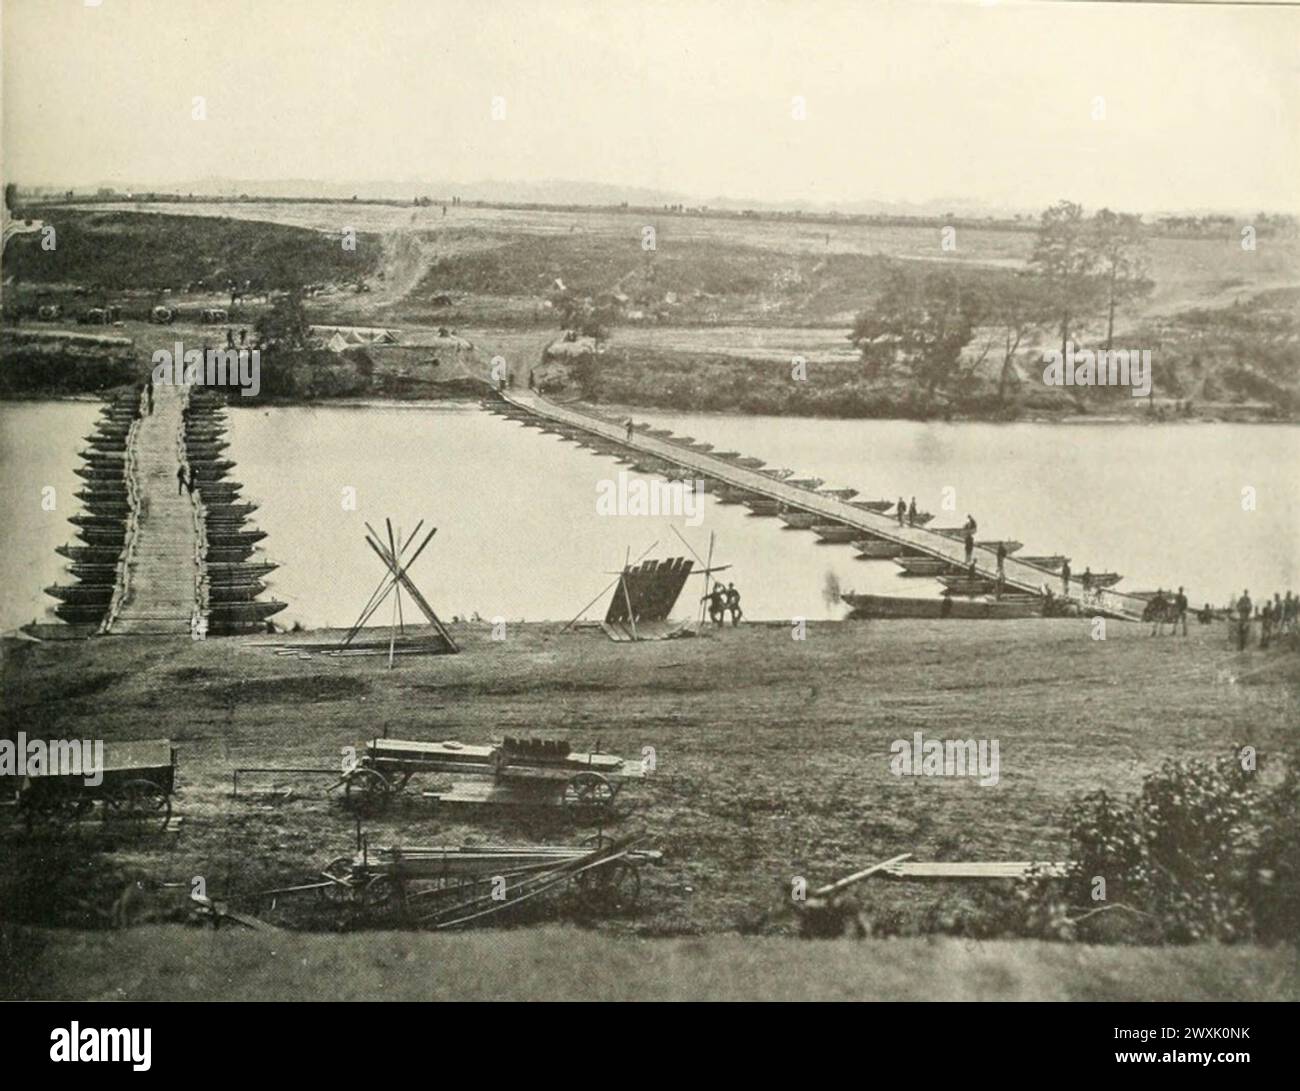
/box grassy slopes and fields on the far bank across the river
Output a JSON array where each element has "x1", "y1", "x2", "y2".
[{"x1": 5, "y1": 202, "x2": 1300, "y2": 419}]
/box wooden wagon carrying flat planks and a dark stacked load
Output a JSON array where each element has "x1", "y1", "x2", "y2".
[{"x1": 341, "y1": 739, "x2": 645, "y2": 817}]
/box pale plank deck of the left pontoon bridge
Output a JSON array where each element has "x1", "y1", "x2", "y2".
[{"x1": 103, "y1": 384, "x2": 203, "y2": 636}]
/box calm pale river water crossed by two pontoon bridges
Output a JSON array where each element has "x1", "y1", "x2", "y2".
[{"x1": 0, "y1": 402, "x2": 1300, "y2": 628}]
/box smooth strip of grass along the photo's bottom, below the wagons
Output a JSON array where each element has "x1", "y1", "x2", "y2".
[{"x1": 0, "y1": 926, "x2": 1300, "y2": 1001}]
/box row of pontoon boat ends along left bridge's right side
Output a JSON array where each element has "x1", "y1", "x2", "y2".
[{"x1": 185, "y1": 391, "x2": 287, "y2": 636}]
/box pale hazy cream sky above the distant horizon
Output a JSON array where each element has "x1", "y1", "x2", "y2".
[{"x1": 3, "y1": 0, "x2": 1300, "y2": 211}]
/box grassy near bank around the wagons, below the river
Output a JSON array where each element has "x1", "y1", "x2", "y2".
[{"x1": 0, "y1": 620, "x2": 1300, "y2": 935}]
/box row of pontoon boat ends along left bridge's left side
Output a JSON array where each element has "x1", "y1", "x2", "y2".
[{"x1": 46, "y1": 390, "x2": 140, "y2": 625}]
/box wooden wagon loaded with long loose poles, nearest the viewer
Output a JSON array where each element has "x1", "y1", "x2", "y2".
[{"x1": 301, "y1": 837, "x2": 662, "y2": 928}]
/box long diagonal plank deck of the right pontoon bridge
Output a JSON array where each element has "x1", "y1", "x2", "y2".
[{"x1": 501, "y1": 389, "x2": 1147, "y2": 620}]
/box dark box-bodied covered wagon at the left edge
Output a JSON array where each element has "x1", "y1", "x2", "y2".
[{"x1": 18, "y1": 739, "x2": 177, "y2": 831}]
